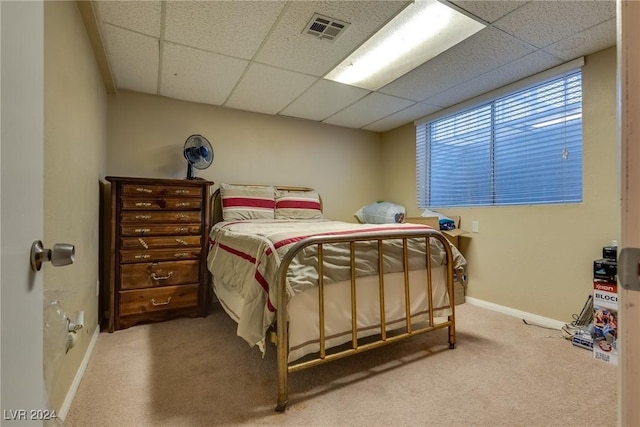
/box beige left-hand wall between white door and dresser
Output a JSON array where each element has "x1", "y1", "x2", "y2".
[{"x1": 43, "y1": 2, "x2": 107, "y2": 410}]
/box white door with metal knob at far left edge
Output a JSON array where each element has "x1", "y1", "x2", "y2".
[{"x1": 0, "y1": 0, "x2": 47, "y2": 426}]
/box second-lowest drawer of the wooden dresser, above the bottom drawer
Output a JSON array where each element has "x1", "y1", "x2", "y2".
[{"x1": 120, "y1": 260, "x2": 200, "y2": 289}]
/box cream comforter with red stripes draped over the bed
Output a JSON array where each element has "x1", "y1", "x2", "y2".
[{"x1": 207, "y1": 220, "x2": 464, "y2": 352}]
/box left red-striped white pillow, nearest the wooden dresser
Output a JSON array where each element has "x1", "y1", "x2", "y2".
[{"x1": 220, "y1": 184, "x2": 276, "y2": 221}]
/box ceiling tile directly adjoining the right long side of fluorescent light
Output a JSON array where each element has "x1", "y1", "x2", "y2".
[{"x1": 380, "y1": 27, "x2": 534, "y2": 101}]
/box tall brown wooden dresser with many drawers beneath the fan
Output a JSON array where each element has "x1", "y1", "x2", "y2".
[{"x1": 102, "y1": 176, "x2": 213, "y2": 332}]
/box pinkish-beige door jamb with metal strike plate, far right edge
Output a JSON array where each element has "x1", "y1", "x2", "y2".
[{"x1": 618, "y1": 1, "x2": 640, "y2": 427}]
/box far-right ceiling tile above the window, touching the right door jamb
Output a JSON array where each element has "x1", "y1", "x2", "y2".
[{"x1": 544, "y1": 18, "x2": 617, "y2": 61}]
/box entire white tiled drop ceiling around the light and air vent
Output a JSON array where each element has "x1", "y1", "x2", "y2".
[{"x1": 93, "y1": 0, "x2": 616, "y2": 132}]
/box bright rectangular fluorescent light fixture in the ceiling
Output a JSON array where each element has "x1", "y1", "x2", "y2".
[{"x1": 325, "y1": 0, "x2": 485, "y2": 90}]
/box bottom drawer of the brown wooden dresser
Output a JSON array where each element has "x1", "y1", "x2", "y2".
[{"x1": 120, "y1": 284, "x2": 198, "y2": 316}]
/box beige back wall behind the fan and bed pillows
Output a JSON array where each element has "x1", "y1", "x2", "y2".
[{"x1": 107, "y1": 91, "x2": 382, "y2": 221}]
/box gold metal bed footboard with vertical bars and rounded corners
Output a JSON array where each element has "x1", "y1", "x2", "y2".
[{"x1": 276, "y1": 230, "x2": 456, "y2": 412}]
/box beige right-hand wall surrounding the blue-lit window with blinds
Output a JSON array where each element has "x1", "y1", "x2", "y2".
[{"x1": 382, "y1": 48, "x2": 620, "y2": 322}]
